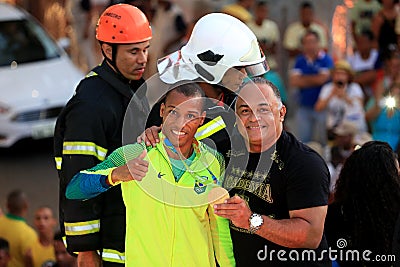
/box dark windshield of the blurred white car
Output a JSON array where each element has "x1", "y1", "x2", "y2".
[{"x1": 0, "y1": 20, "x2": 60, "y2": 66}]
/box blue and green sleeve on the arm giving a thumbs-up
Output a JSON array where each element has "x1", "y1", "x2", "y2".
[{"x1": 66, "y1": 144, "x2": 144, "y2": 200}]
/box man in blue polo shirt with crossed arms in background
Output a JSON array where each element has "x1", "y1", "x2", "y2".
[{"x1": 290, "y1": 31, "x2": 333, "y2": 146}]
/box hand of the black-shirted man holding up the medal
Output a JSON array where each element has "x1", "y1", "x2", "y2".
[{"x1": 214, "y1": 196, "x2": 252, "y2": 229}]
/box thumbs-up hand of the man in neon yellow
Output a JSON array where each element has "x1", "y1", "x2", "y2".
[{"x1": 111, "y1": 150, "x2": 149, "y2": 183}]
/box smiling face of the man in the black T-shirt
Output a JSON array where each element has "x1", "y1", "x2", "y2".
[{"x1": 236, "y1": 83, "x2": 286, "y2": 153}]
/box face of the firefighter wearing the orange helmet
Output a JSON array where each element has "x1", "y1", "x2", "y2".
[{"x1": 102, "y1": 41, "x2": 150, "y2": 80}]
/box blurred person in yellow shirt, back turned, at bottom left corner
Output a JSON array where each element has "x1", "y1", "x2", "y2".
[{"x1": 0, "y1": 190, "x2": 37, "y2": 267}]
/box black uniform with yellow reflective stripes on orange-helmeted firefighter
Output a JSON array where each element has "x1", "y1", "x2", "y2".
[{"x1": 54, "y1": 61, "x2": 149, "y2": 266}]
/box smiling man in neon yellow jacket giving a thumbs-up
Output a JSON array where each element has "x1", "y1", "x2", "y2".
[{"x1": 66, "y1": 83, "x2": 235, "y2": 267}]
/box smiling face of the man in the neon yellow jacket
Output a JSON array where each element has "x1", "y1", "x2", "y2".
[{"x1": 160, "y1": 90, "x2": 206, "y2": 155}]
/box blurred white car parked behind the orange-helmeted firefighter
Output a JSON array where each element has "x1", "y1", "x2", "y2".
[{"x1": 0, "y1": 3, "x2": 84, "y2": 147}]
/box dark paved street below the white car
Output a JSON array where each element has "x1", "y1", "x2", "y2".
[{"x1": 0, "y1": 139, "x2": 58, "y2": 228}]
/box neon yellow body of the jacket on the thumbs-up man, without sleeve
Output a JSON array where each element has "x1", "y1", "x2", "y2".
[{"x1": 122, "y1": 140, "x2": 235, "y2": 267}]
